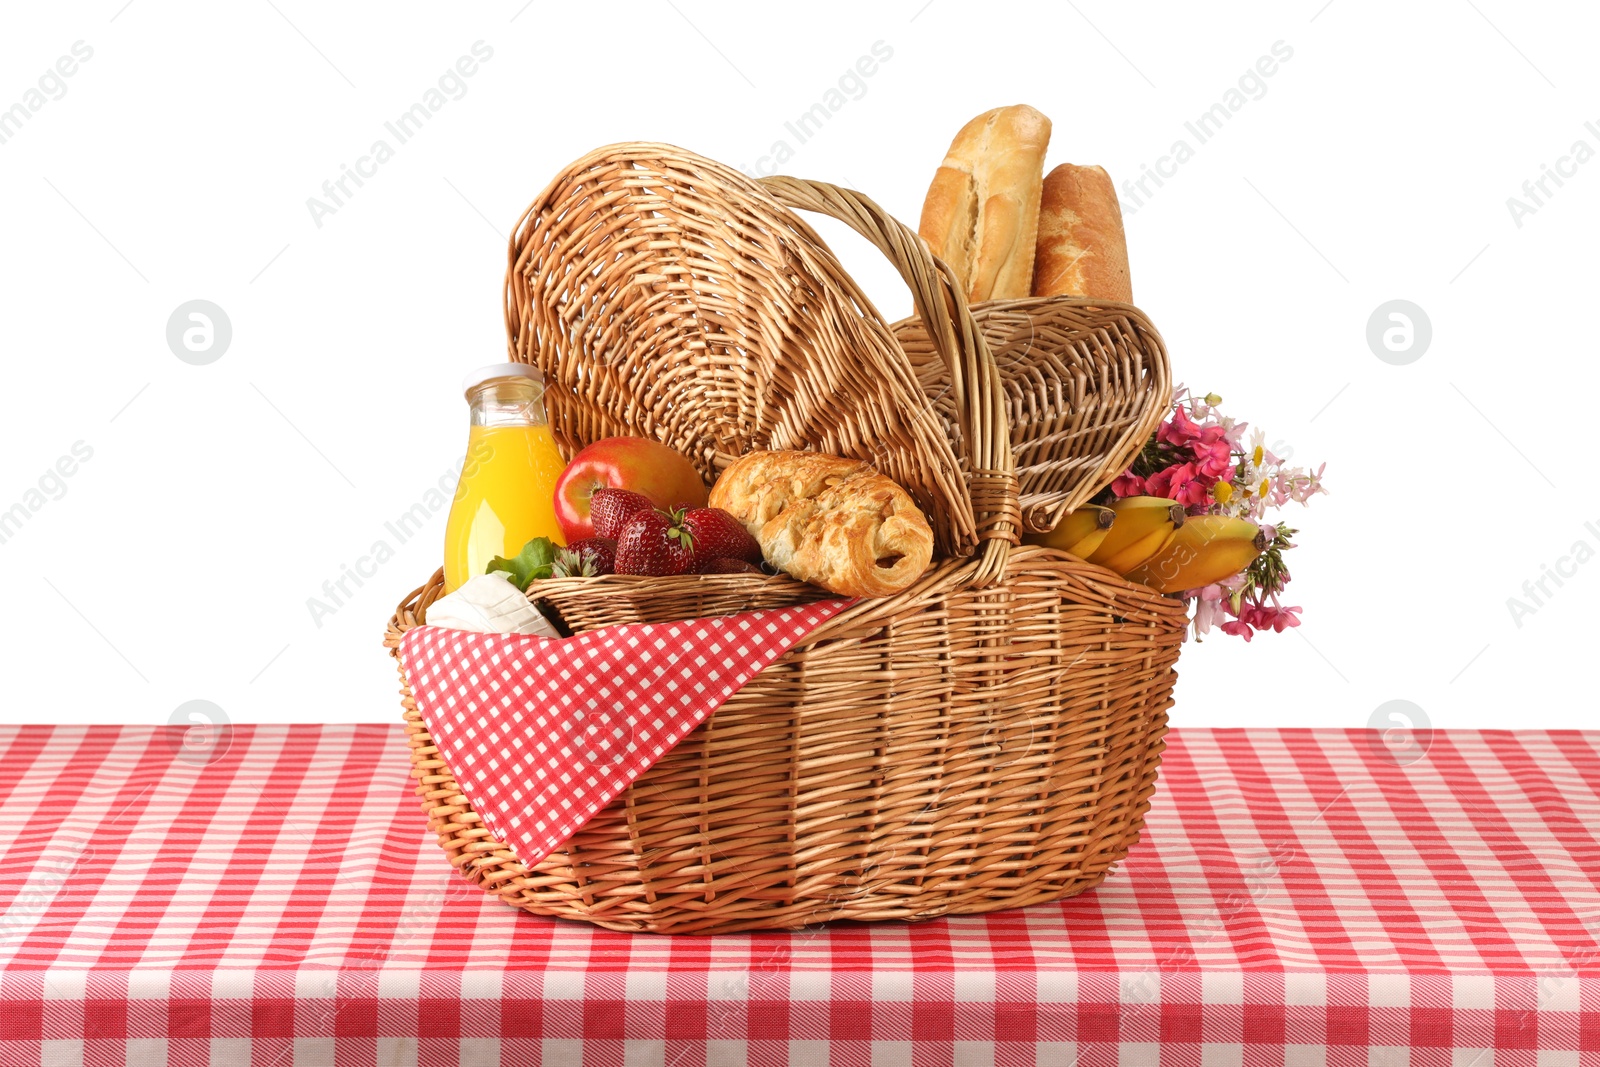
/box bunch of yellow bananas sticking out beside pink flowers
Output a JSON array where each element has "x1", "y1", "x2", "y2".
[{"x1": 1024, "y1": 496, "x2": 1266, "y2": 593}]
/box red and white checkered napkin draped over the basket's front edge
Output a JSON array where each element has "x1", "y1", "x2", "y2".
[{"x1": 400, "y1": 600, "x2": 851, "y2": 867}]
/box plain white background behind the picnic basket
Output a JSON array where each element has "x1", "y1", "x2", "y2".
[{"x1": 0, "y1": 0, "x2": 1600, "y2": 728}]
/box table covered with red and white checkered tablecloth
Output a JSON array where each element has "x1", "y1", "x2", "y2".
[{"x1": 0, "y1": 725, "x2": 1600, "y2": 1067}]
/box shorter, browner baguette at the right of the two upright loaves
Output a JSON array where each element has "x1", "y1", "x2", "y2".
[{"x1": 1034, "y1": 163, "x2": 1133, "y2": 304}]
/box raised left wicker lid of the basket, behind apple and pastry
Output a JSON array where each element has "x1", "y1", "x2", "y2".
[{"x1": 506, "y1": 142, "x2": 979, "y2": 558}]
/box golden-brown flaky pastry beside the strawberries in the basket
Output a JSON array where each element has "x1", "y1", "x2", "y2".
[{"x1": 710, "y1": 451, "x2": 933, "y2": 597}]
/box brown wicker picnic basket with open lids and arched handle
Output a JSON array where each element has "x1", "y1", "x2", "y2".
[{"x1": 386, "y1": 144, "x2": 1186, "y2": 934}]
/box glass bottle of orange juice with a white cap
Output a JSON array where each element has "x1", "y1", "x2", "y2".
[{"x1": 445, "y1": 363, "x2": 566, "y2": 592}]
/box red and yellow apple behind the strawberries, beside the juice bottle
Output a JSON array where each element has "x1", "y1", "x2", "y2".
[{"x1": 554, "y1": 437, "x2": 710, "y2": 544}]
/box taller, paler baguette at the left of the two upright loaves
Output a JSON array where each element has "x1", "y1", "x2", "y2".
[{"x1": 917, "y1": 104, "x2": 1050, "y2": 302}]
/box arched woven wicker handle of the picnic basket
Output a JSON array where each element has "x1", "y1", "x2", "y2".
[{"x1": 760, "y1": 176, "x2": 1022, "y2": 587}]
